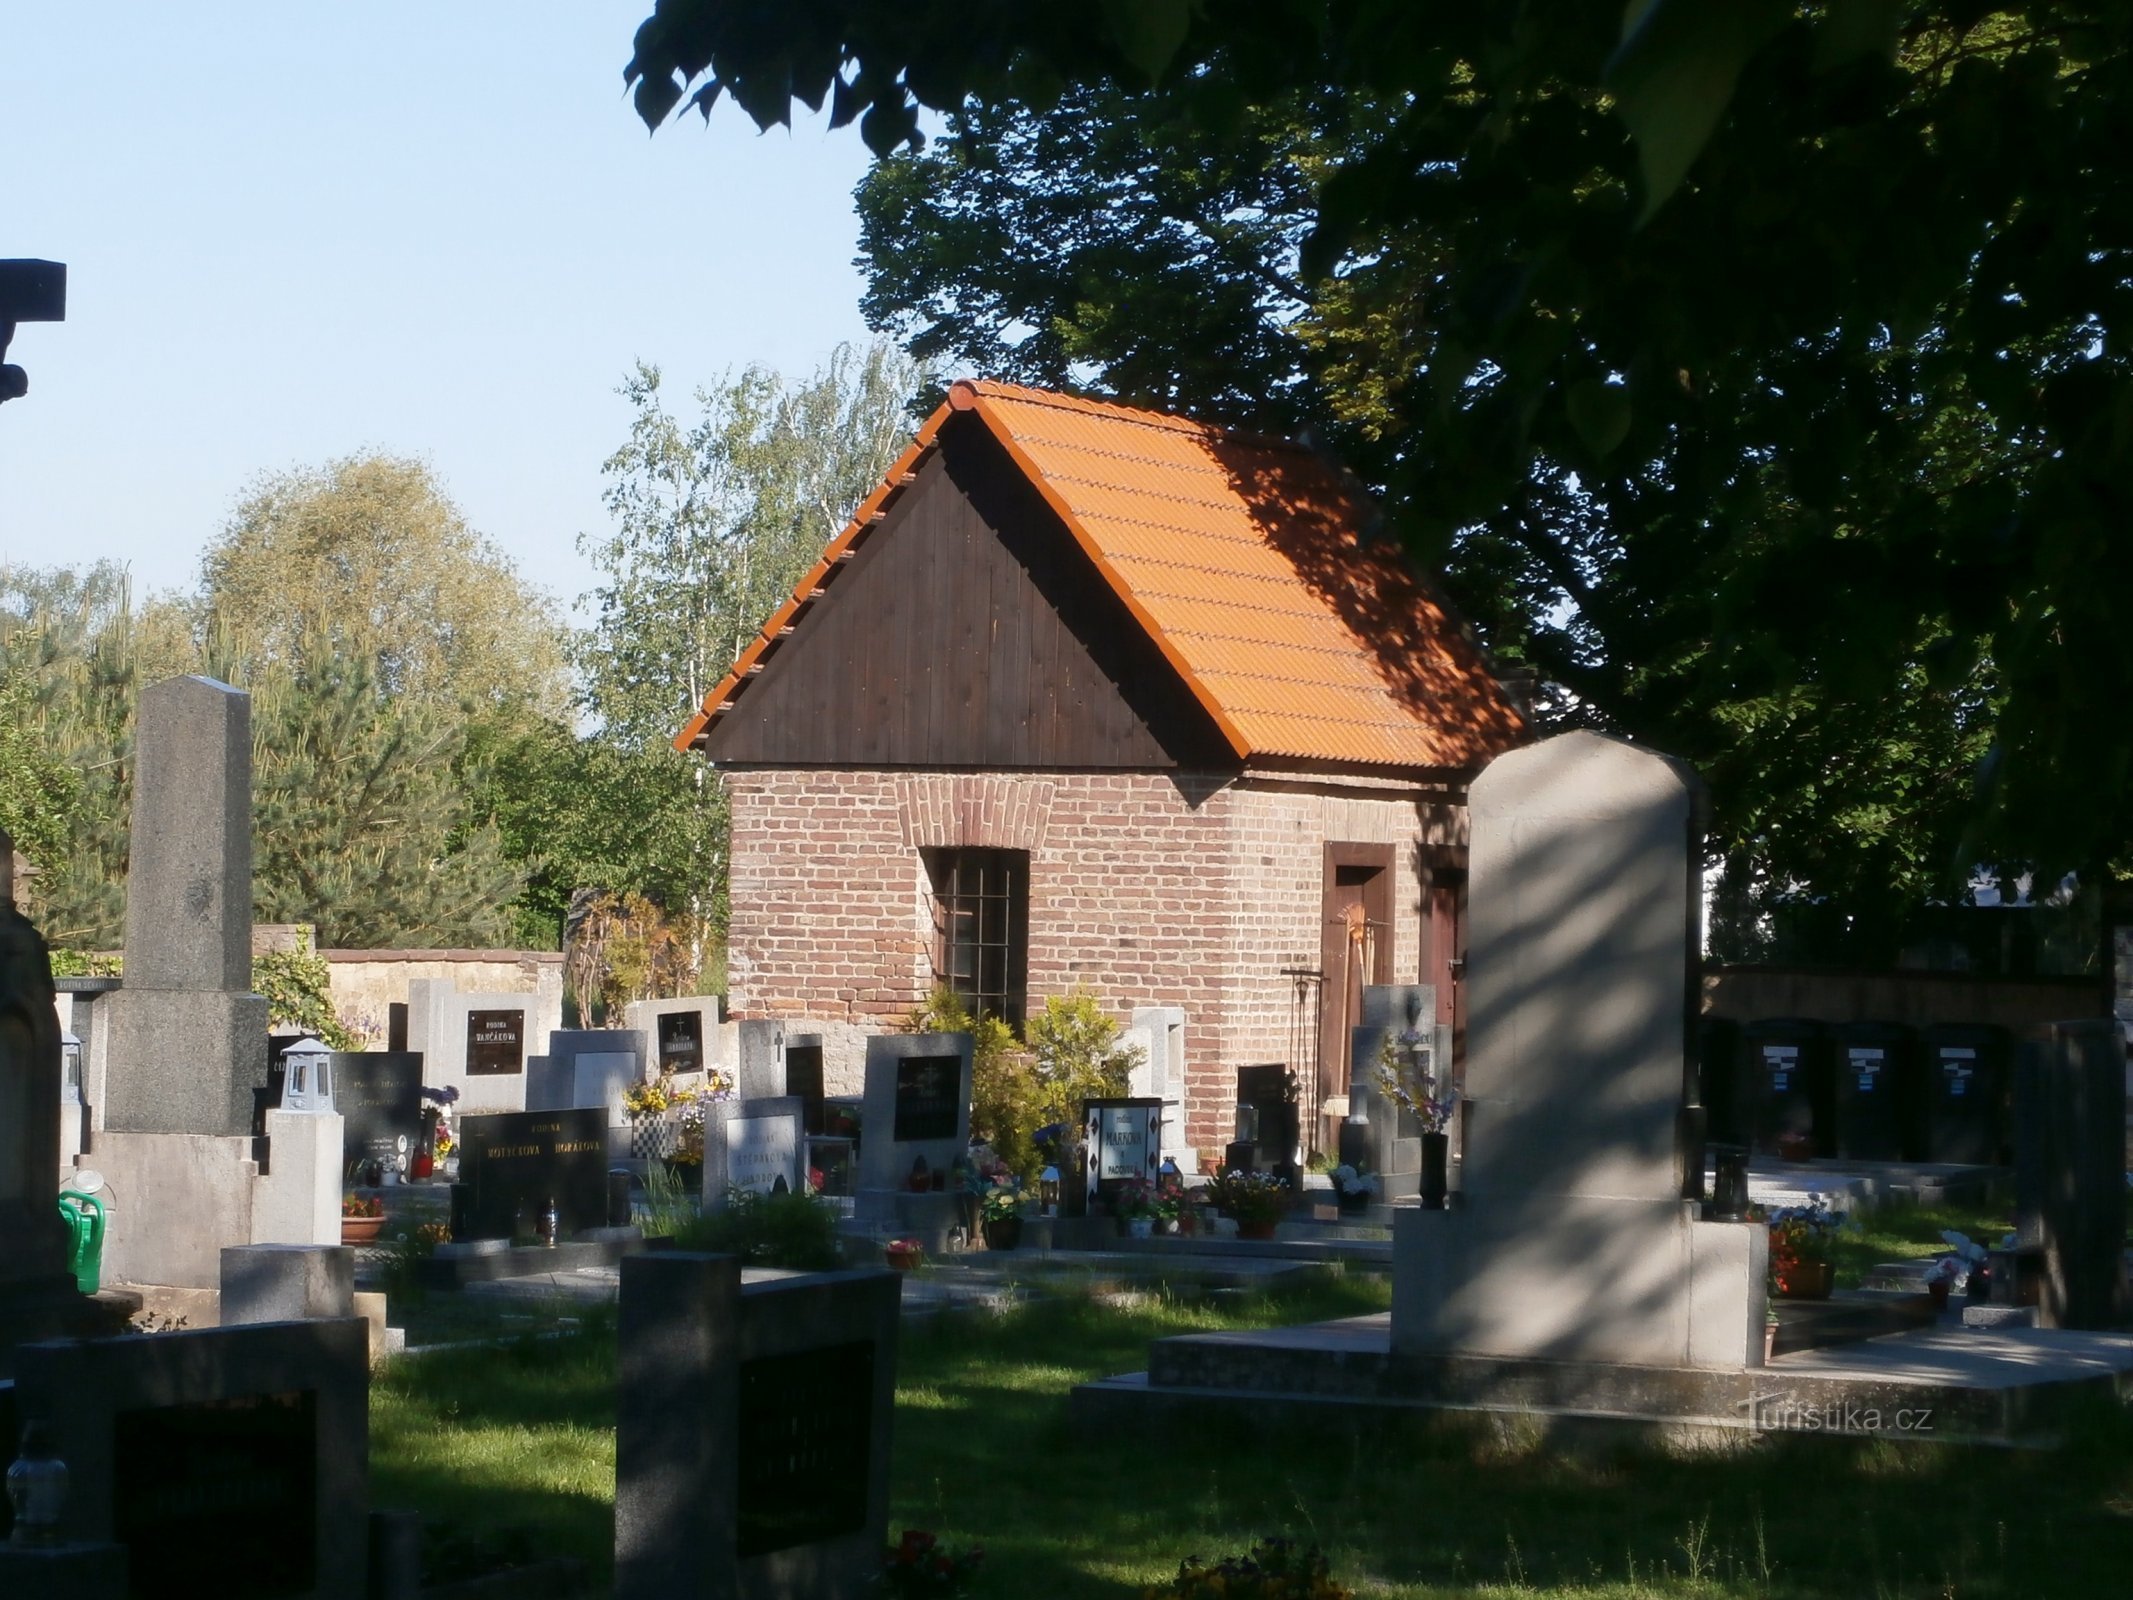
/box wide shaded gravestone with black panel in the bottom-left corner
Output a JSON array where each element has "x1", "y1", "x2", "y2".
[{"x1": 15, "y1": 1318, "x2": 369, "y2": 1600}]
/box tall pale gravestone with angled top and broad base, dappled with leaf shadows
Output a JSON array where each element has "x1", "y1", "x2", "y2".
[{"x1": 1393, "y1": 734, "x2": 1768, "y2": 1372}]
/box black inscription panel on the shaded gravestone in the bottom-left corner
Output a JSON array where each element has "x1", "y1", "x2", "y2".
[{"x1": 111, "y1": 1391, "x2": 318, "y2": 1600}]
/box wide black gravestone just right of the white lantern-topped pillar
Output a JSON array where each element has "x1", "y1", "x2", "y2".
[{"x1": 454, "y1": 1105, "x2": 608, "y2": 1239}]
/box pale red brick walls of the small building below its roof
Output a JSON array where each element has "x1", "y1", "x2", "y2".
[{"x1": 723, "y1": 770, "x2": 1463, "y2": 1148}]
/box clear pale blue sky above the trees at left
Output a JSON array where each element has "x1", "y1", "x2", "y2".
[{"x1": 0, "y1": 0, "x2": 866, "y2": 618}]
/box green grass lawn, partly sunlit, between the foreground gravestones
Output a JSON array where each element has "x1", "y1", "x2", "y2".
[{"x1": 371, "y1": 1210, "x2": 2133, "y2": 1600}]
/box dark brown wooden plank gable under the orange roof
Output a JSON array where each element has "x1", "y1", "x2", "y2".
[{"x1": 702, "y1": 416, "x2": 1237, "y2": 770}]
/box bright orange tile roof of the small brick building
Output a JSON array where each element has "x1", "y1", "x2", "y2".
[{"x1": 674, "y1": 382, "x2": 1525, "y2": 770}]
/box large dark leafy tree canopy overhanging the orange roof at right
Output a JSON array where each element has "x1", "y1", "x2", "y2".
[{"x1": 631, "y1": 0, "x2": 2133, "y2": 951}]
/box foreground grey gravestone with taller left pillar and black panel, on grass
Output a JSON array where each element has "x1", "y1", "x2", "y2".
[{"x1": 614, "y1": 1252, "x2": 902, "y2": 1600}]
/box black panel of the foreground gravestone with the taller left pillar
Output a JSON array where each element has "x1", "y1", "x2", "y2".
[{"x1": 734, "y1": 1342, "x2": 875, "y2": 1559}]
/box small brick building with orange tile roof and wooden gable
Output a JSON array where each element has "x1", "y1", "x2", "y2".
[{"x1": 676, "y1": 382, "x2": 1523, "y2": 1148}]
